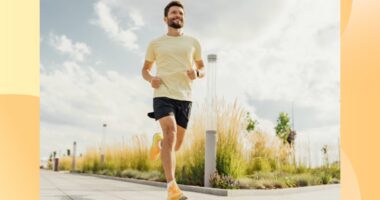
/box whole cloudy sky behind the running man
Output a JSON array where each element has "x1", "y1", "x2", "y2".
[{"x1": 40, "y1": 0, "x2": 340, "y2": 164}]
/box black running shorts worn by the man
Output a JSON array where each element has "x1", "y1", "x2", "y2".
[{"x1": 148, "y1": 97, "x2": 191, "y2": 129}]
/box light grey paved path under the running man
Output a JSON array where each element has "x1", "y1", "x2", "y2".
[{"x1": 40, "y1": 170, "x2": 339, "y2": 200}]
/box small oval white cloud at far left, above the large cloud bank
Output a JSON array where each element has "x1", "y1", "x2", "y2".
[{"x1": 50, "y1": 33, "x2": 91, "y2": 61}]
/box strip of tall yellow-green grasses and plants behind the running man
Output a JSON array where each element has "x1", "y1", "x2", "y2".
[{"x1": 72, "y1": 102, "x2": 340, "y2": 189}]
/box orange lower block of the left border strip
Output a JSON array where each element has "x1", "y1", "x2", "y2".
[{"x1": 0, "y1": 95, "x2": 40, "y2": 200}]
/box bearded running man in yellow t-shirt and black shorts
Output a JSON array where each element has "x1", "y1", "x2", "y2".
[{"x1": 142, "y1": 1, "x2": 205, "y2": 200}]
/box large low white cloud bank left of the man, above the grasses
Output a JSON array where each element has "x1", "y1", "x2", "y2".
[{"x1": 41, "y1": 62, "x2": 157, "y2": 155}]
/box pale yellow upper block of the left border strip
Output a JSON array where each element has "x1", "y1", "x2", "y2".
[{"x1": 0, "y1": 0, "x2": 40, "y2": 96}]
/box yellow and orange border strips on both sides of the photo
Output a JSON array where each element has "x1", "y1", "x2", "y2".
[{"x1": 0, "y1": 0, "x2": 380, "y2": 200}]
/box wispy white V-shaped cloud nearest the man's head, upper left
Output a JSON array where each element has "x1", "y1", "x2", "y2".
[{"x1": 91, "y1": 1, "x2": 144, "y2": 50}]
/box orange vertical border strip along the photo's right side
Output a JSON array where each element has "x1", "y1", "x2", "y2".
[{"x1": 341, "y1": 0, "x2": 380, "y2": 200}]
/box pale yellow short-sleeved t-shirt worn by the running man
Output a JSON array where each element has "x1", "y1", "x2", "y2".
[{"x1": 145, "y1": 35, "x2": 202, "y2": 101}]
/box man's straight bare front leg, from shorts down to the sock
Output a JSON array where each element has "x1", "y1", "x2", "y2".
[{"x1": 159, "y1": 115, "x2": 177, "y2": 183}]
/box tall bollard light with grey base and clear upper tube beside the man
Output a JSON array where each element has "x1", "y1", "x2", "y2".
[{"x1": 204, "y1": 54, "x2": 217, "y2": 187}]
